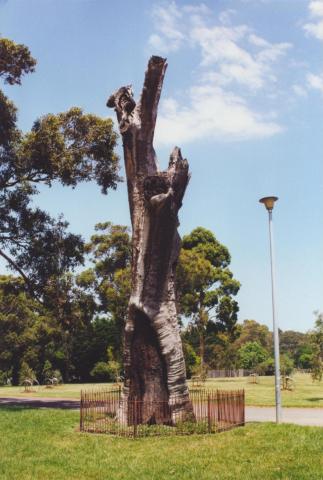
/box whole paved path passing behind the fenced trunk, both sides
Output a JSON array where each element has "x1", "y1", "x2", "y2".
[{"x1": 0, "y1": 397, "x2": 323, "y2": 427}]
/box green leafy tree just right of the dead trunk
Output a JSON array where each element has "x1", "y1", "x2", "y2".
[{"x1": 177, "y1": 227, "x2": 240, "y2": 363}]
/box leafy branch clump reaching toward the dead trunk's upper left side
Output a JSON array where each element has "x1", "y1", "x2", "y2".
[{"x1": 17, "y1": 107, "x2": 120, "y2": 193}]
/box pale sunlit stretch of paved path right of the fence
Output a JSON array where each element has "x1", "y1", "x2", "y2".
[{"x1": 246, "y1": 407, "x2": 323, "y2": 427}]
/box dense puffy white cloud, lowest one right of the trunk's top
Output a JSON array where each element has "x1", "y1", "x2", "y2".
[{"x1": 156, "y1": 85, "x2": 282, "y2": 145}]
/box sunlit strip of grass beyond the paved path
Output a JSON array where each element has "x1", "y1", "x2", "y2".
[{"x1": 0, "y1": 374, "x2": 323, "y2": 406}]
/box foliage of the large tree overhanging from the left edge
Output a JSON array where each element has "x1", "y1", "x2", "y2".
[{"x1": 0, "y1": 39, "x2": 120, "y2": 299}]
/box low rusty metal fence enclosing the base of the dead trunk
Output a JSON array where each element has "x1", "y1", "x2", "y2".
[{"x1": 80, "y1": 390, "x2": 245, "y2": 437}]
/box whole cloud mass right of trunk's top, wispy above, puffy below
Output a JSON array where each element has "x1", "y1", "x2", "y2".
[{"x1": 149, "y1": 1, "x2": 291, "y2": 144}]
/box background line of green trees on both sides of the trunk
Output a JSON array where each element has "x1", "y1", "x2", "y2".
[{"x1": 0, "y1": 222, "x2": 323, "y2": 384}]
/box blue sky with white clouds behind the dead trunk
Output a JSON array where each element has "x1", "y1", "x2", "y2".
[{"x1": 0, "y1": 0, "x2": 323, "y2": 331}]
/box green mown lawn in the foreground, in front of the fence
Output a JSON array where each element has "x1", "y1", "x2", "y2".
[{"x1": 0, "y1": 407, "x2": 323, "y2": 480}]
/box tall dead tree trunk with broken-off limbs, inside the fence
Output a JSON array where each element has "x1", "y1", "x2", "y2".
[{"x1": 107, "y1": 56, "x2": 191, "y2": 423}]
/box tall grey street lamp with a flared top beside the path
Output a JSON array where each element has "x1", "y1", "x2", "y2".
[{"x1": 259, "y1": 197, "x2": 281, "y2": 423}]
